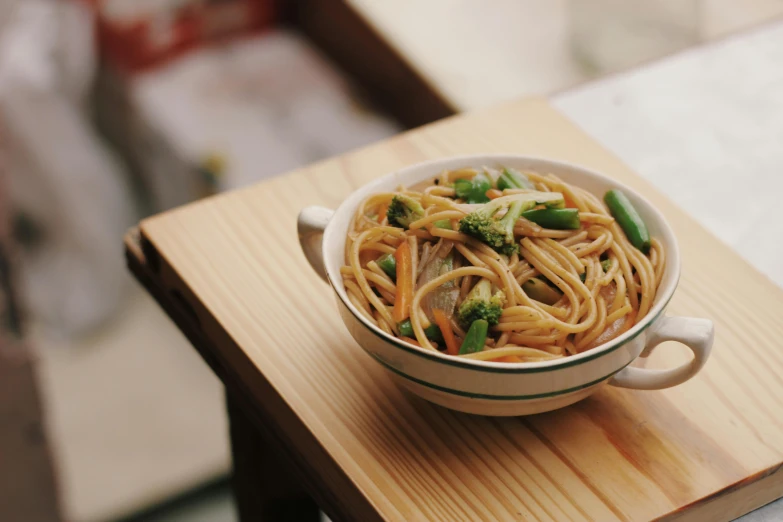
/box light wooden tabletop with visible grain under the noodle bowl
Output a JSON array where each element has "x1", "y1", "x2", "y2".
[{"x1": 141, "y1": 100, "x2": 783, "y2": 521}]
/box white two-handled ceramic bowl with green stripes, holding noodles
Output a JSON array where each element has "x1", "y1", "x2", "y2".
[{"x1": 298, "y1": 155, "x2": 713, "y2": 415}]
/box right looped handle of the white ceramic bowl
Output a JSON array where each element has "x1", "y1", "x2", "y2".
[{"x1": 609, "y1": 317, "x2": 715, "y2": 390}]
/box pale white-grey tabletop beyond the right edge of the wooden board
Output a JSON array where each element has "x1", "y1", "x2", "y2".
[{"x1": 552, "y1": 21, "x2": 783, "y2": 522}]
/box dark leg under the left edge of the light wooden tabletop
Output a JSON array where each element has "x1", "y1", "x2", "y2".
[{"x1": 226, "y1": 394, "x2": 320, "y2": 522}]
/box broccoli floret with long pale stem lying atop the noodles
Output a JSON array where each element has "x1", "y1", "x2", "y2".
[{"x1": 459, "y1": 192, "x2": 565, "y2": 256}]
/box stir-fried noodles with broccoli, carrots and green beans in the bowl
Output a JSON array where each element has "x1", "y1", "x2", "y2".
[{"x1": 340, "y1": 167, "x2": 666, "y2": 363}]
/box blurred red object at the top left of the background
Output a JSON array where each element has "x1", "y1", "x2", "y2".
[{"x1": 81, "y1": 0, "x2": 277, "y2": 73}]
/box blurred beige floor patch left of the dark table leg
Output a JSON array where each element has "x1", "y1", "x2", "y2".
[{"x1": 35, "y1": 288, "x2": 230, "y2": 521}]
